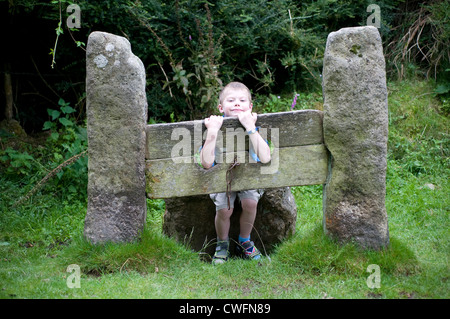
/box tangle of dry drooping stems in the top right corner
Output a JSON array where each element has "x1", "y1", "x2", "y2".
[{"x1": 384, "y1": 0, "x2": 450, "y2": 83}]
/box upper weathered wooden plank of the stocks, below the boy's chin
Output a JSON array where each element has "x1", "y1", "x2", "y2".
[{"x1": 146, "y1": 110, "x2": 323, "y2": 159}]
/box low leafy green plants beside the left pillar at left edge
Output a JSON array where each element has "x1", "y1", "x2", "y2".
[{"x1": 0, "y1": 99, "x2": 87, "y2": 200}]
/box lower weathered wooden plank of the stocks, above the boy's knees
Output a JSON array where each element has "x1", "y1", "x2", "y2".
[{"x1": 146, "y1": 144, "x2": 328, "y2": 198}]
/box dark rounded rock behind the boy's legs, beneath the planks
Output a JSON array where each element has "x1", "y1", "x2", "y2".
[{"x1": 163, "y1": 187, "x2": 297, "y2": 256}]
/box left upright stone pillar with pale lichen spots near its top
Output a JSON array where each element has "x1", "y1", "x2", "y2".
[{"x1": 84, "y1": 32, "x2": 147, "y2": 243}]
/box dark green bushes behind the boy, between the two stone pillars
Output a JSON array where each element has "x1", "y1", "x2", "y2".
[{"x1": 106, "y1": 0, "x2": 398, "y2": 121}]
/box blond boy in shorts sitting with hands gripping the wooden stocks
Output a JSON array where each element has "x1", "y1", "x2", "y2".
[{"x1": 200, "y1": 82, "x2": 270, "y2": 264}]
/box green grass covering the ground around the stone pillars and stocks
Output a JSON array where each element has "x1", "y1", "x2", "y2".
[{"x1": 0, "y1": 82, "x2": 450, "y2": 299}]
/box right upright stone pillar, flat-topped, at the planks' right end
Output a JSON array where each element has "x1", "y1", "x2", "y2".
[{"x1": 323, "y1": 26, "x2": 389, "y2": 249}]
